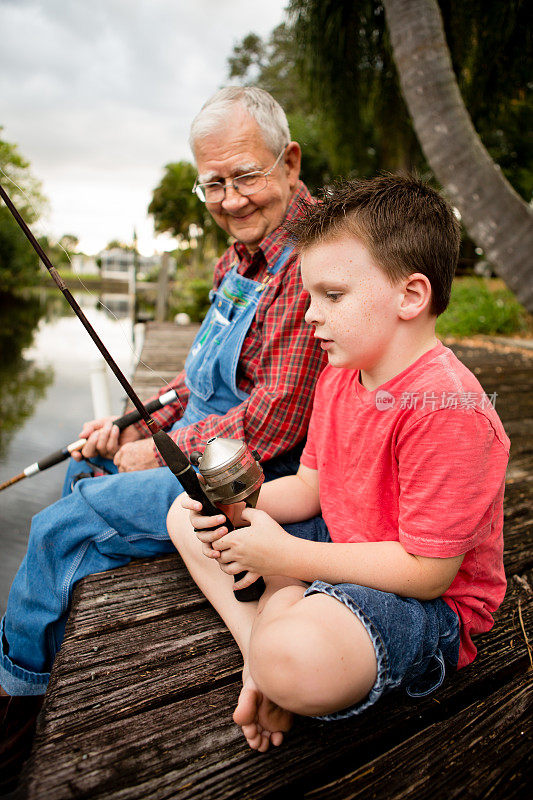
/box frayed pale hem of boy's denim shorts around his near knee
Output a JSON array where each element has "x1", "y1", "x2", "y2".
[{"x1": 304, "y1": 581, "x2": 387, "y2": 722}]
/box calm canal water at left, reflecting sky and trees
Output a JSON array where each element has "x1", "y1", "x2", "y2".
[{"x1": 0, "y1": 290, "x2": 143, "y2": 614}]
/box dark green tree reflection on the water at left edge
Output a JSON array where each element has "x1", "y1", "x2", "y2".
[{"x1": 0, "y1": 293, "x2": 54, "y2": 458}]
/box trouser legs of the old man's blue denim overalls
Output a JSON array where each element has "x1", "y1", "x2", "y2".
[{"x1": 0, "y1": 451, "x2": 298, "y2": 695}]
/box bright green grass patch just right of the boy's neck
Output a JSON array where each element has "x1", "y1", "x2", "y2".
[{"x1": 437, "y1": 276, "x2": 533, "y2": 337}]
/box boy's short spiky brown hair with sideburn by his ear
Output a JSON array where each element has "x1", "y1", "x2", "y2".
[{"x1": 287, "y1": 175, "x2": 461, "y2": 315}]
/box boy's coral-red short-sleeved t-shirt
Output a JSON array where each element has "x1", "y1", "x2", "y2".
[{"x1": 301, "y1": 342, "x2": 510, "y2": 667}]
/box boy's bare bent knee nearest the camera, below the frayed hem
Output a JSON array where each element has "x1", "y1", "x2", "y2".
[{"x1": 246, "y1": 586, "x2": 377, "y2": 724}]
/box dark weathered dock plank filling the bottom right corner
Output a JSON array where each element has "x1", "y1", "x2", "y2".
[{"x1": 306, "y1": 675, "x2": 533, "y2": 800}]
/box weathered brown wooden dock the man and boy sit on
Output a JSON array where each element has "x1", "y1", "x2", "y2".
[{"x1": 18, "y1": 325, "x2": 533, "y2": 800}]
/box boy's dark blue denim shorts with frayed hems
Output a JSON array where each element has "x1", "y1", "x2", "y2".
[{"x1": 283, "y1": 516, "x2": 460, "y2": 720}]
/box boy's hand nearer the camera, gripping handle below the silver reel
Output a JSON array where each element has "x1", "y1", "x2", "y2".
[{"x1": 211, "y1": 508, "x2": 294, "y2": 575}]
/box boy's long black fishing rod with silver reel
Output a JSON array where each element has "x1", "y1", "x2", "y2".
[{"x1": 0, "y1": 183, "x2": 265, "y2": 601}]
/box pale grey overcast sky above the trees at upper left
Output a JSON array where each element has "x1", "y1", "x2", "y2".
[{"x1": 0, "y1": 0, "x2": 287, "y2": 253}]
